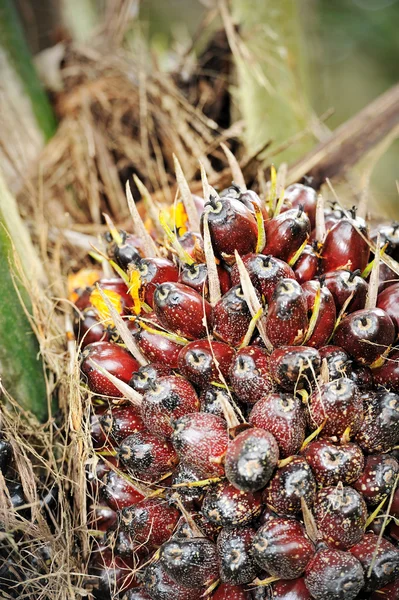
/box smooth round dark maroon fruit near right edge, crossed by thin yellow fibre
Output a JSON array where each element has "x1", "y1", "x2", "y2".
[{"x1": 334, "y1": 308, "x2": 395, "y2": 365}]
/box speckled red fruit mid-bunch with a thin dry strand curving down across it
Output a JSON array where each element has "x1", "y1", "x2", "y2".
[{"x1": 178, "y1": 340, "x2": 235, "y2": 387}]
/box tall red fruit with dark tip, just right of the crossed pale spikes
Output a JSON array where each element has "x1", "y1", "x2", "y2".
[{"x1": 266, "y1": 279, "x2": 308, "y2": 348}]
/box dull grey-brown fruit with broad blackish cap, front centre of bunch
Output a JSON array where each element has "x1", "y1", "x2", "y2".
[{"x1": 225, "y1": 428, "x2": 279, "y2": 492}]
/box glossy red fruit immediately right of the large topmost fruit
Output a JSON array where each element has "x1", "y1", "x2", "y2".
[{"x1": 262, "y1": 206, "x2": 310, "y2": 262}]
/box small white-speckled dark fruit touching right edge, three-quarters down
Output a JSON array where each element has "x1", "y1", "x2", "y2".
[{"x1": 353, "y1": 454, "x2": 399, "y2": 506}]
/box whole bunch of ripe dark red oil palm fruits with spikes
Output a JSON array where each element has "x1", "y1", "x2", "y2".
[{"x1": 75, "y1": 166, "x2": 399, "y2": 600}]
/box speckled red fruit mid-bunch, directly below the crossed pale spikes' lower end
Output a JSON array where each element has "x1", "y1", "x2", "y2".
[{"x1": 230, "y1": 346, "x2": 274, "y2": 404}]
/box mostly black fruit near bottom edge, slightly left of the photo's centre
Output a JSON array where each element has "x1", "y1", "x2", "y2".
[{"x1": 160, "y1": 537, "x2": 219, "y2": 588}]
